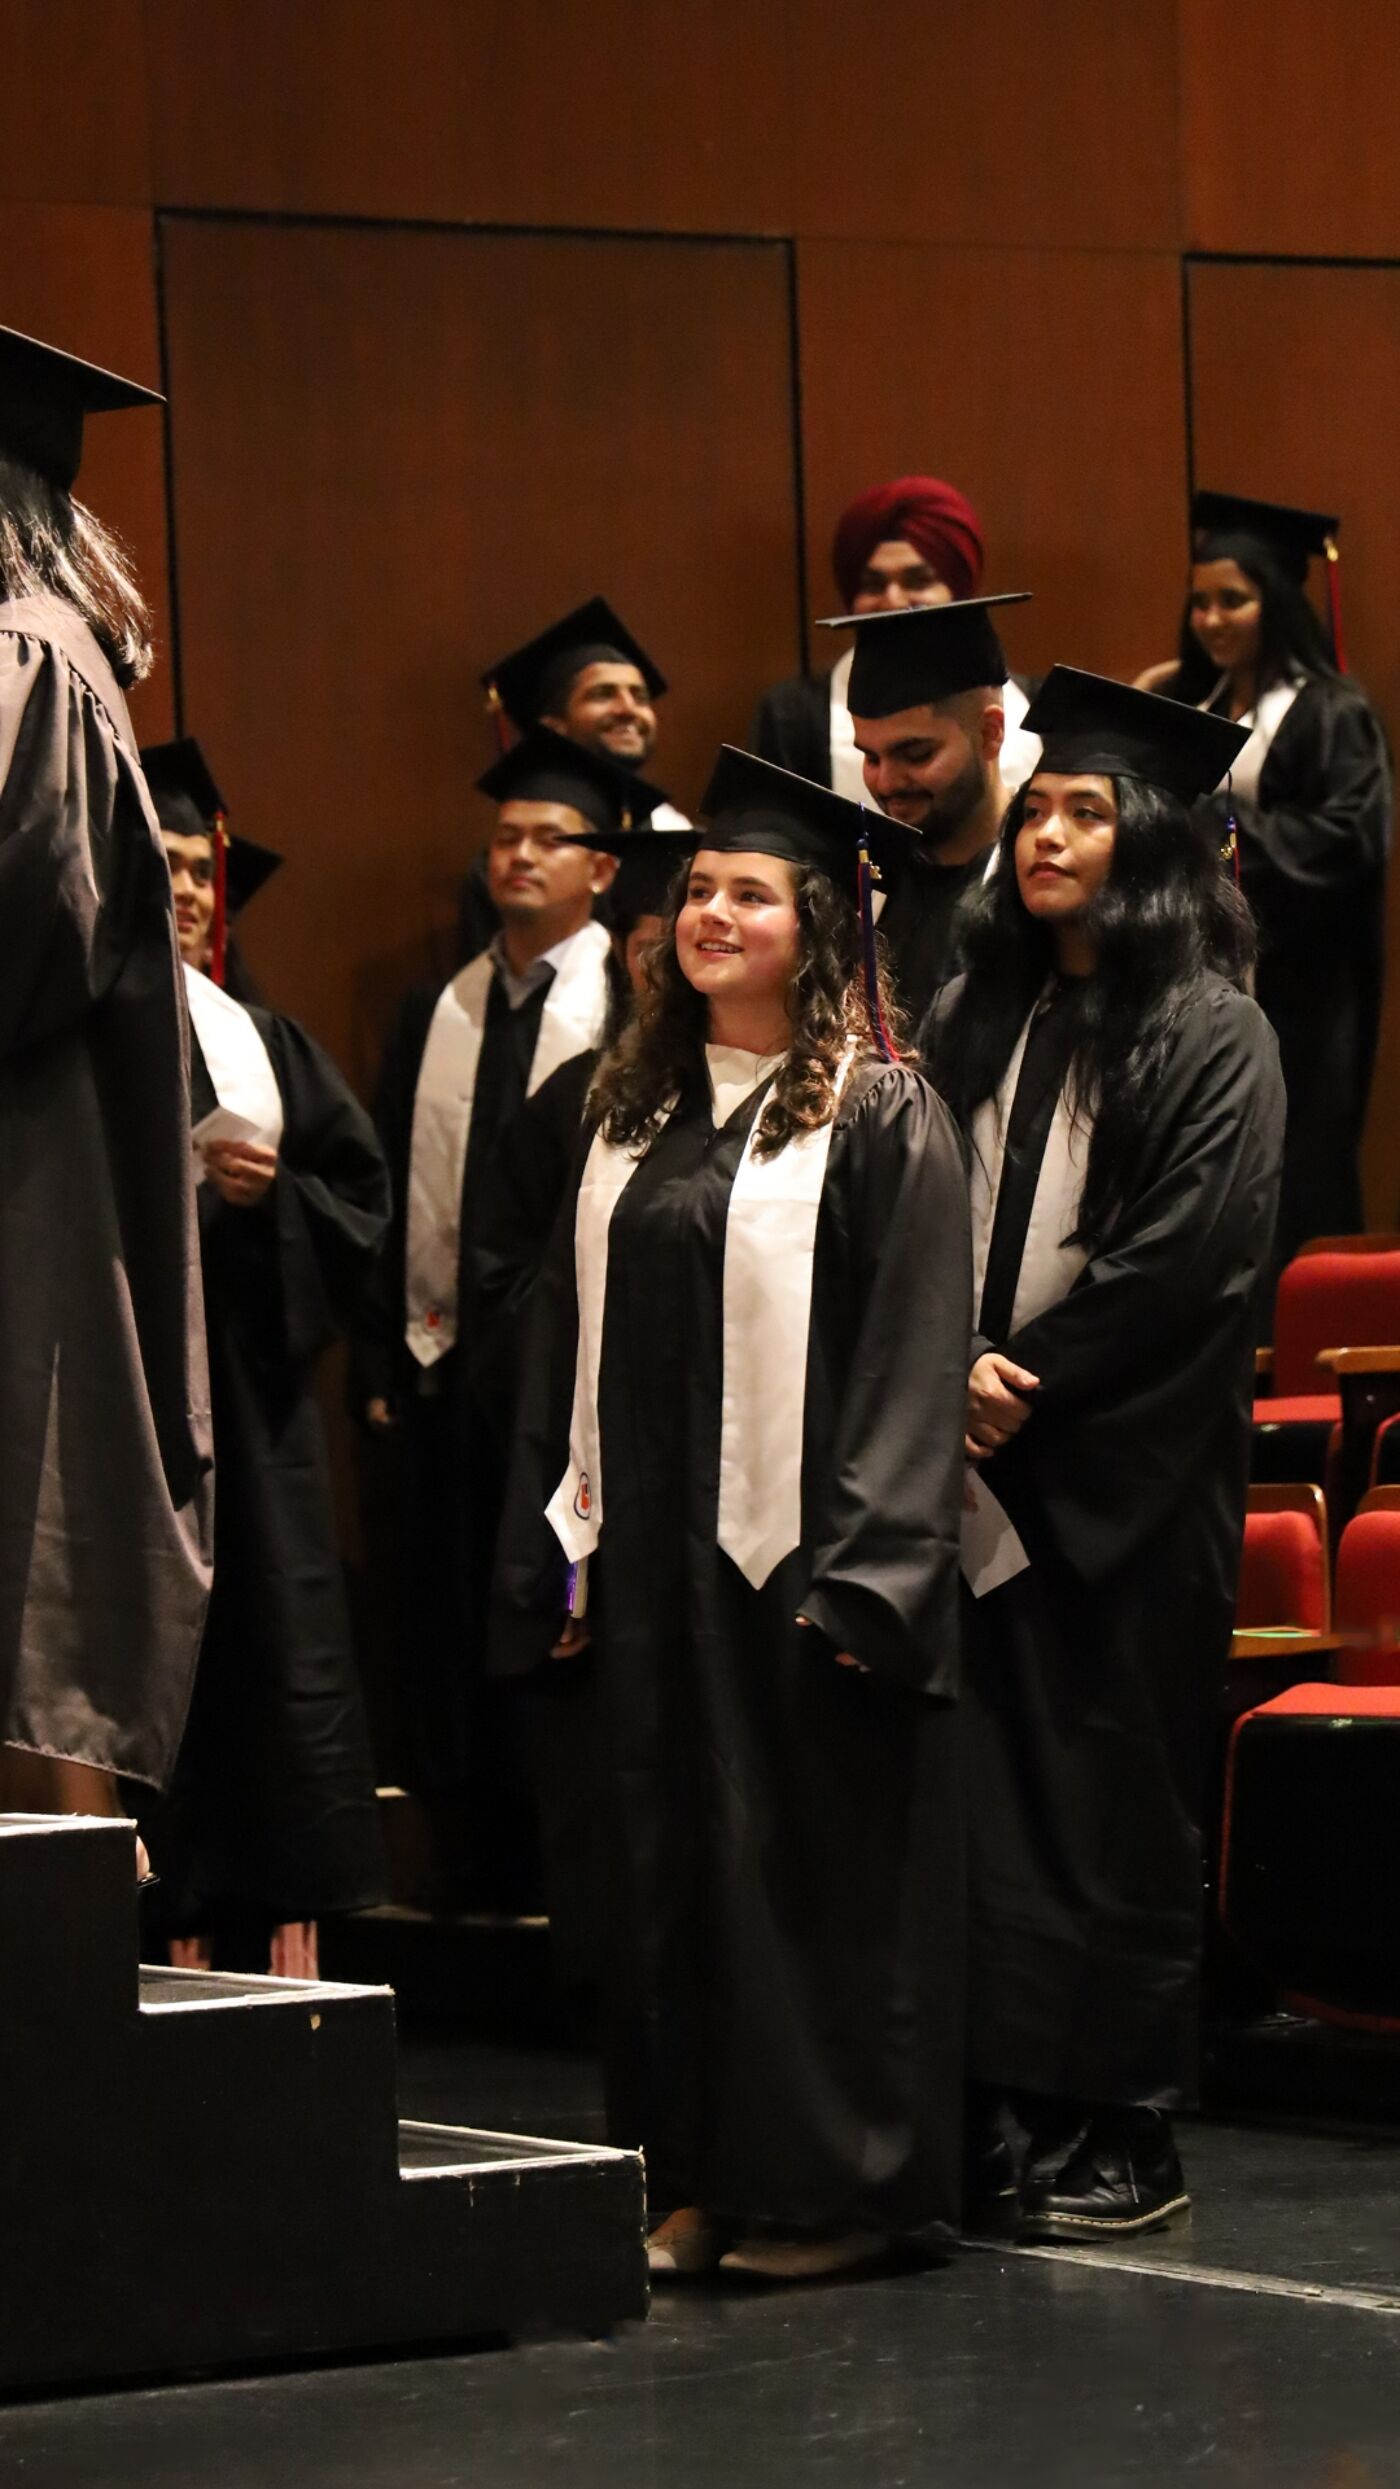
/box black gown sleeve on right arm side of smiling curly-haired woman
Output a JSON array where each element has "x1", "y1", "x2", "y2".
[{"x1": 800, "y1": 1068, "x2": 972, "y2": 1695}]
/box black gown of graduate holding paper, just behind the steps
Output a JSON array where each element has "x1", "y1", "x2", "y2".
[{"x1": 152, "y1": 1011, "x2": 389, "y2": 1929}]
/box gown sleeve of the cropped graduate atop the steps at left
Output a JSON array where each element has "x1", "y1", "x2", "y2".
[{"x1": 0, "y1": 632, "x2": 152, "y2": 1058}]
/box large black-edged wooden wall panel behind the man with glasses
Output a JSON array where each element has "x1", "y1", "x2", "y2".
[{"x1": 164, "y1": 222, "x2": 797, "y2": 1078}]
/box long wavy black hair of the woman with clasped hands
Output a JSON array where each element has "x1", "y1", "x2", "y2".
[{"x1": 924, "y1": 777, "x2": 1253, "y2": 1247}]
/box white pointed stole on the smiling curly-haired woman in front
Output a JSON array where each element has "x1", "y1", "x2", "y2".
[{"x1": 546, "y1": 1055, "x2": 852, "y2": 1590}]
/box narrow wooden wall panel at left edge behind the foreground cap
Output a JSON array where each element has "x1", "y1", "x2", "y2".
[{"x1": 0, "y1": 202, "x2": 174, "y2": 742}]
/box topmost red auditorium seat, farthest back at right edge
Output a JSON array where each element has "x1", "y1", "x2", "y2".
[{"x1": 1253, "y1": 1237, "x2": 1400, "y2": 1481}]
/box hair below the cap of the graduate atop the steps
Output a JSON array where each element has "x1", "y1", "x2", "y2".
[{"x1": 0, "y1": 455, "x2": 154, "y2": 689}]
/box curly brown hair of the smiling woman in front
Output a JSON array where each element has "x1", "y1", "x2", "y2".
[{"x1": 588, "y1": 864, "x2": 907, "y2": 1157}]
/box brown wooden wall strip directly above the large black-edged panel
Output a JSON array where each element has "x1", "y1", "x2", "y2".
[{"x1": 147, "y1": 0, "x2": 802, "y2": 234}]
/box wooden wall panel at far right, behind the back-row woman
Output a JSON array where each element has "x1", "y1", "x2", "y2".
[{"x1": 1191, "y1": 266, "x2": 1400, "y2": 1227}]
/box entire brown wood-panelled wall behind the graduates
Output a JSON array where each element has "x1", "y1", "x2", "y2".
[{"x1": 10, "y1": 0, "x2": 1400, "y2": 1225}]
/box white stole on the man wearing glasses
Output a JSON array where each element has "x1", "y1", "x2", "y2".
[{"x1": 404, "y1": 923, "x2": 608, "y2": 1366}]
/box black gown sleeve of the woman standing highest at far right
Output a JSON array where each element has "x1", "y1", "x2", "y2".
[{"x1": 1211, "y1": 682, "x2": 1395, "y2": 901}]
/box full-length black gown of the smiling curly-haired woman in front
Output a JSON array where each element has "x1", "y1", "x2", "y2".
[{"x1": 498, "y1": 1065, "x2": 969, "y2": 2233}]
